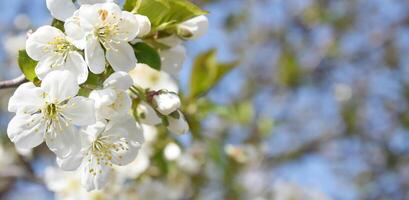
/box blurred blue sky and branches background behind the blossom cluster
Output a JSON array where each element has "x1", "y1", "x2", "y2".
[{"x1": 0, "y1": 0, "x2": 409, "y2": 200}]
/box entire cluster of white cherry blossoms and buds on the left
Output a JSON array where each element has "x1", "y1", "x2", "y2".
[{"x1": 7, "y1": 0, "x2": 208, "y2": 191}]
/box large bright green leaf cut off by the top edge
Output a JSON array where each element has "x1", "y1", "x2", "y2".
[{"x1": 131, "y1": 0, "x2": 207, "y2": 30}]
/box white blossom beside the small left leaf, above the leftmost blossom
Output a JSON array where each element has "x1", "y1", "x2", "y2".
[{"x1": 26, "y1": 26, "x2": 88, "y2": 84}]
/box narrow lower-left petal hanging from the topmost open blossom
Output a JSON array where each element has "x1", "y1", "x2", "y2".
[{"x1": 85, "y1": 36, "x2": 105, "y2": 74}]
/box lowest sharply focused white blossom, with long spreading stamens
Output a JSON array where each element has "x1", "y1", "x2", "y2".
[{"x1": 57, "y1": 116, "x2": 144, "y2": 191}]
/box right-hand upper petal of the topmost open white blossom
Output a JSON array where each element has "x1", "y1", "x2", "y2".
[{"x1": 114, "y1": 11, "x2": 139, "y2": 41}]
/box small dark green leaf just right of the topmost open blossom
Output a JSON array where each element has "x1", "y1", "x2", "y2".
[{"x1": 132, "y1": 42, "x2": 161, "y2": 70}]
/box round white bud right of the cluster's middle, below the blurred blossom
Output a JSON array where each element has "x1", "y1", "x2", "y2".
[{"x1": 153, "y1": 92, "x2": 180, "y2": 115}]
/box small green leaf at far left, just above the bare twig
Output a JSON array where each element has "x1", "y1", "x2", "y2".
[{"x1": 18, "y1": 50, "x2": 38, "y2": 82}]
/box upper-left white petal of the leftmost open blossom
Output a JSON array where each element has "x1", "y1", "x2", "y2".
[{"x1": 8, "y1": 82, "x2": 44, "y2": 113}]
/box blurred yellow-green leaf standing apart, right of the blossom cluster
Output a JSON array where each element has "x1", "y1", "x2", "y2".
[{"x1": 190, "y1": 49, "x2": 238, "y2": 98}]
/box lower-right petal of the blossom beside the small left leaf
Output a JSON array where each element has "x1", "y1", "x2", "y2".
[{"x1": 63, "y1": 51, "x2": 88, "y2": 84}]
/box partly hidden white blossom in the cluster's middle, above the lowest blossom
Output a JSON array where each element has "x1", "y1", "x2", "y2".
[{"x1": 89, "y1": 72, "x2": 133, "y2": 119}]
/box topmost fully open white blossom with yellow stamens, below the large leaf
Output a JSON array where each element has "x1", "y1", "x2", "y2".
[{"x1": 65, "y1": 3, "x2": 144, "y2": 74}]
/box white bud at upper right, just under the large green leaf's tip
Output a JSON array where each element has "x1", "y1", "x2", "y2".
[{"x1": 177, "y1": 15, "x2": 209, "y2": 40}]
